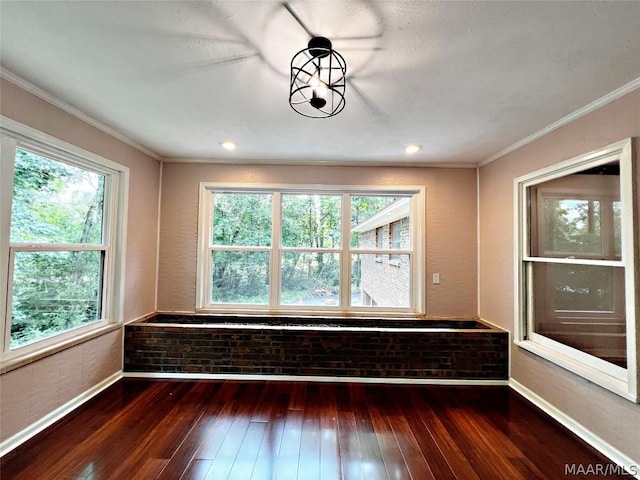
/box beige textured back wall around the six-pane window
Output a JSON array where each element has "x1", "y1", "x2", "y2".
[{"x1": 158, "y1": 163, "x2": 477, "y2": 316}]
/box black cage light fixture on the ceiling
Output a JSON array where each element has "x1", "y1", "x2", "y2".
[{"x1": 289, "y1": 37, "x2": 347, "y2": 118}]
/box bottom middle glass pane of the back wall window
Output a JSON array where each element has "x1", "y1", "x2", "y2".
[{"x1": 281, "y1": 252, "x2": 340, "y2": 305}]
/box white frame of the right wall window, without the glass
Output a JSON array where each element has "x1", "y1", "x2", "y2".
[{"x1": 514, "y1": 138, "x2": 639, "y2": 402}]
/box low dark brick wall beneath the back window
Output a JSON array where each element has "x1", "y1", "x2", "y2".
[{"x1": 124, "y1": 316, "x2": 508, "y2": 379}]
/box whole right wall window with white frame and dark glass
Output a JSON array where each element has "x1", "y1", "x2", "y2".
[{"x1": 516, "y1": 141, "x2": 637, "y2": 400}]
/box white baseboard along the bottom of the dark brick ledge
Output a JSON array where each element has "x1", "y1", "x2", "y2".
[{"x1": 123, "y1": 372, "x2": 509, "y2": 386}]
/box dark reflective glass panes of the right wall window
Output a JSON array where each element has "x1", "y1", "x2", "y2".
[{"x1": 529, "y1": 160, "x2": 627, "y2": 367}]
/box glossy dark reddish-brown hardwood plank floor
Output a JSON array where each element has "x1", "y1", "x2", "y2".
[{"x1": 0, "y1": 379, "x2": 631, "y2": 480}]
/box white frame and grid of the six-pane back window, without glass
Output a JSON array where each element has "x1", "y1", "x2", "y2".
[{"x1": 195, "y1": 182, "x2": 426, "y2": 317}]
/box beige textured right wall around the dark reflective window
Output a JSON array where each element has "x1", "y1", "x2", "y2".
[{"x1": 479, "y1": 90, "x2": 640, "y2": 463}]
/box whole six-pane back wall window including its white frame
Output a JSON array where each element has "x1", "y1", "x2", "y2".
[{"x1": 197, "y1": 183, "x2": 424, "y2": 315}]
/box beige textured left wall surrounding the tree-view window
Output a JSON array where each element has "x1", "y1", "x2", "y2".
[{"x1": 0, "y1": 79, "x2": 160, "y2": 439}]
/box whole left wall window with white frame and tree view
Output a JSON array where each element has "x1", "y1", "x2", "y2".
[{"x1": 1, "y1": 121, "x2": 127, "y2": 359}]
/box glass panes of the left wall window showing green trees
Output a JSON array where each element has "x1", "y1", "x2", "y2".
[{"x1": 9, "y1": 149, "x2": 108, "y2": 350}]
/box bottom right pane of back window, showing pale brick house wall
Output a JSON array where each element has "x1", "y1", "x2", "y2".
[{"x1": 351, "y1": 254, "x2": 411, "y2": 308}]
